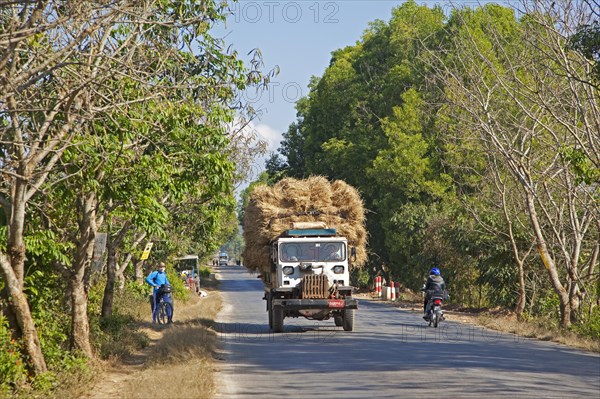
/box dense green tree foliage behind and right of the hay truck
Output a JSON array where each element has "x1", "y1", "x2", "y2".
[{"x1": 261, "y1": 1, "x2": 598, "y2": 322}]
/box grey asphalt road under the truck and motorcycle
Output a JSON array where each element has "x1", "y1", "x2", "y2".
[{"x1": 217, "y1": 266, "x2": 600, "y2": 399}]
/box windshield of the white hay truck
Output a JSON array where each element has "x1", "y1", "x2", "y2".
[{"x1": 279, "y1": 241, "x2": 346, "y2": 262}]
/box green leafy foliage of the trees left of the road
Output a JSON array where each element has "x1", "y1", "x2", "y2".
[{"x1": 0, "y1": 1, "x2": 268, "y2": 390}]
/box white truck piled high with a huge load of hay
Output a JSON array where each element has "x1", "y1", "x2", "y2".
[{"x1": 242, "y1": 176, "x2": 367, "y2": 333}]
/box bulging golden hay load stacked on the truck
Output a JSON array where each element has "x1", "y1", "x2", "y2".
[{"x1": 243, "y1": 176, "x2": 367, "y2": 271}]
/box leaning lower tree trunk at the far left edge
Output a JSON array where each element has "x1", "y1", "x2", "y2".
[{"x1": 0, "y1": 252, "x2": 48, "y2": 374}]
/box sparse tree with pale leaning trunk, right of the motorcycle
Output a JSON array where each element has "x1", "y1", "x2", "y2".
[{"x1": 432, "y1": 1, "x2": 598, "y2": 327}]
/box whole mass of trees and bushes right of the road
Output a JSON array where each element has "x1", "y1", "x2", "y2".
[{"x1": 250, "y1": 0, "x2": 600, "y2": 340}]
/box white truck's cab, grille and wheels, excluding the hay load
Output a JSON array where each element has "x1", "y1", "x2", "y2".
[{"x1": 260, "y1": 223, "x2": 358, "y2": 333}]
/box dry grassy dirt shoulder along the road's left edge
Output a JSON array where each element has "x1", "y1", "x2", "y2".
[{"x1": 82, "y1": 290, "x2": 222, "y2": 399}]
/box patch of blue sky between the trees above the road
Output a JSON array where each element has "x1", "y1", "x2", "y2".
[{"x1": 213, "y1": 0, "x2": 400, "y2": 178}]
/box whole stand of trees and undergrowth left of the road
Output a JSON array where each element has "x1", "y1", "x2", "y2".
[{"x1": 0, "y1": 0, "x2": 273, "y2": 397}]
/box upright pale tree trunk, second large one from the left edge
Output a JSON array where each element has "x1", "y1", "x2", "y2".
[{"x1": 70, "y1": 193, "x2": 96, "y2": 357}]
